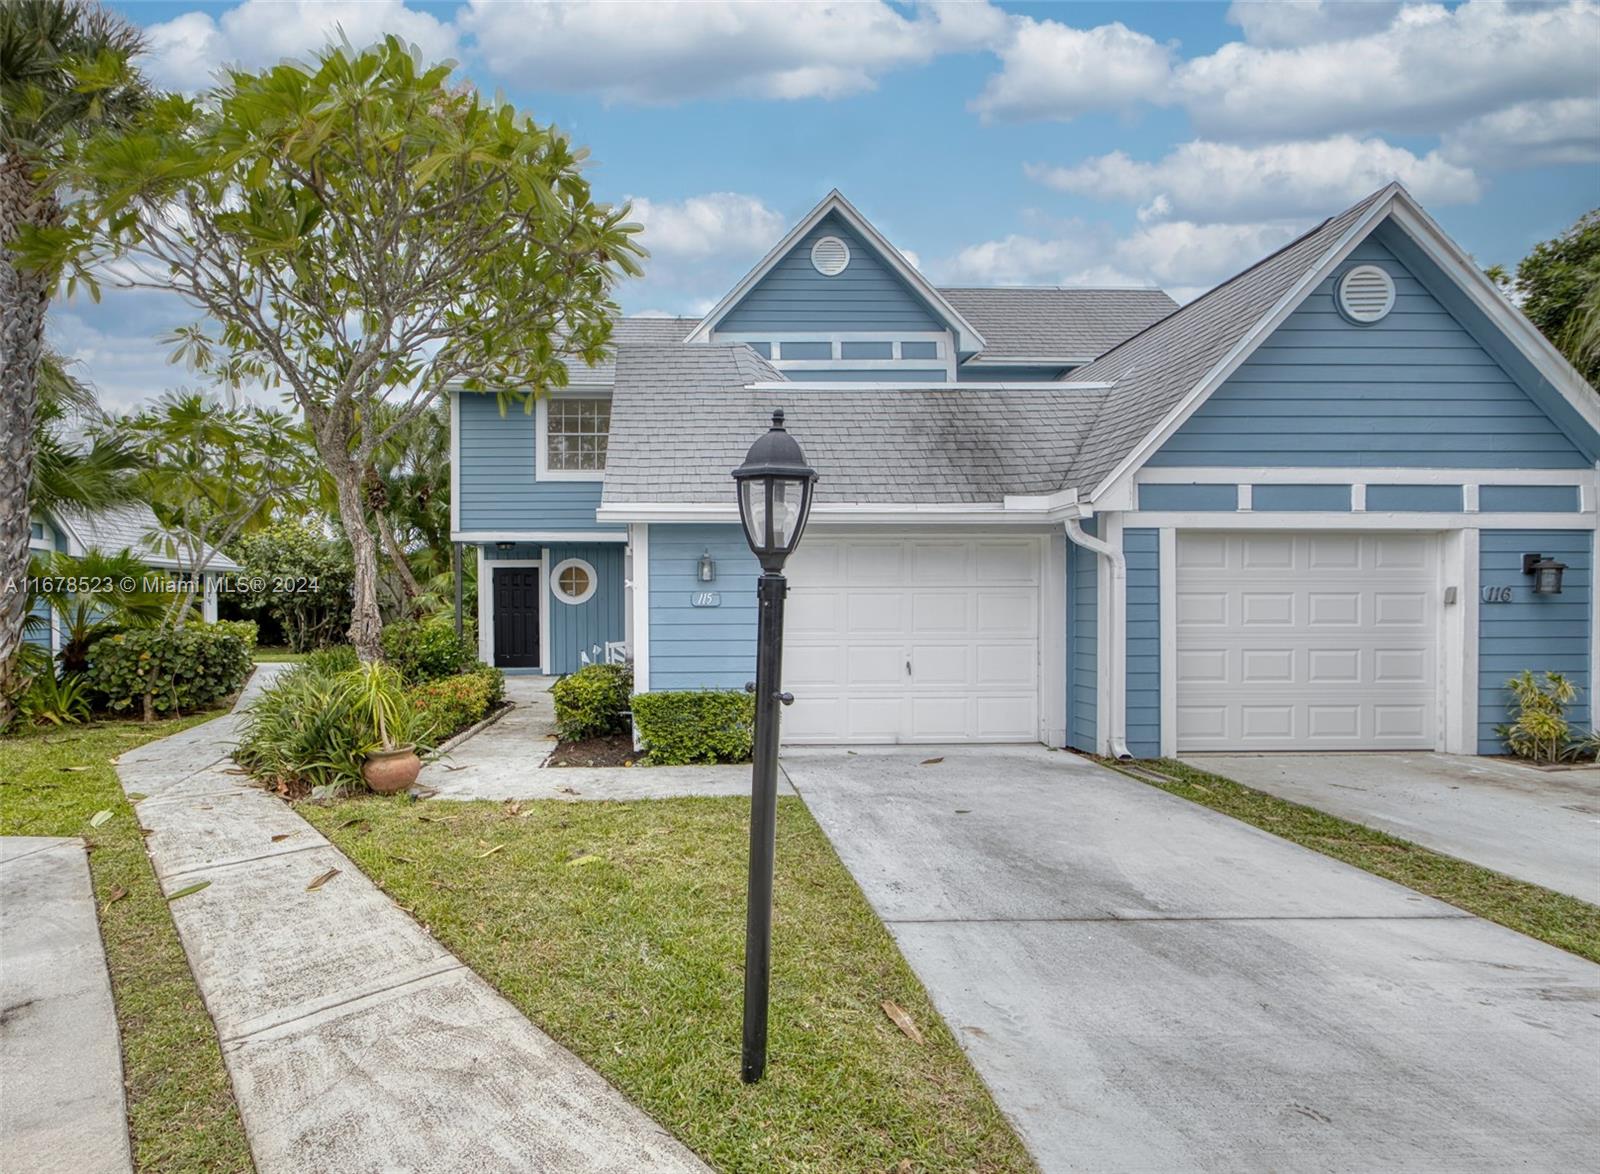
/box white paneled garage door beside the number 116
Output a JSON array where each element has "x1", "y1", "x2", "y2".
[{"x1": 1176, "y1": 531, "x2": 1438, "y2": 750}]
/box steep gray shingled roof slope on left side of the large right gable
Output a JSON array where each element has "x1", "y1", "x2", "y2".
[{"x1": 1064, "y1": 187, "x2": 1390, "y2": 494}]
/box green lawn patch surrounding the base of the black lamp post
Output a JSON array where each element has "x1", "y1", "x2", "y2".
[{"x1": 299, "y1": 797, "x2": 1034, "y2": 1174}]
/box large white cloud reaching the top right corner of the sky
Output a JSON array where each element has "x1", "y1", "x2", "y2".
[{"x1": 1174, "y1": 0, "x2": 1600, "y2": 139}]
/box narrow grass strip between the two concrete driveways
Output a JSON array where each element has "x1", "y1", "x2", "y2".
[{"x1": 1126, "y1": 758, "x2": 1600, "y2": 961}]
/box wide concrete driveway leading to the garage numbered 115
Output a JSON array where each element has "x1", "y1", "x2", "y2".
[{"x1": 779, "y1": 747, "x2": 1600, "y2": 1172}]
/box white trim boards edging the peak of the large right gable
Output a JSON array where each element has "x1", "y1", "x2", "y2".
[{"x1": 1088, "y1": 182, "x2": 1600, "y2": 509}]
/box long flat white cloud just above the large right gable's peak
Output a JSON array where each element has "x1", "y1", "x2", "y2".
[{"x1": 1027, "y1": 134, "x2": 1478, "y2": 224}]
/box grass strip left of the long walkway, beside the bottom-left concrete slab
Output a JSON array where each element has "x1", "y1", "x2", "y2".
[{"x1": 0, "y1": 713, "x2": 253, "y2": 1174}]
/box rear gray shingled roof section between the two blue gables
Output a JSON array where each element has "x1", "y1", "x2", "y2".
[{"x1": 939, "y1": 286, "x2": 1178, "y2": 361}]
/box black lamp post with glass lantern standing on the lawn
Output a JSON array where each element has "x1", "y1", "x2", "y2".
[{"x1": 733, "y1": 411, "x2": 816, "y2": 1084}]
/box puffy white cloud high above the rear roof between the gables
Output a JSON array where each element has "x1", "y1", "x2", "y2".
[{"x1": 971, "y1": 16, "x2": 1173, "y2": 122}]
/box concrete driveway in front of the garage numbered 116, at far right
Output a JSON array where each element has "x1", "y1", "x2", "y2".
[{"x1": 1184, "y1": 753, "x2": 1600, "y2": 905}]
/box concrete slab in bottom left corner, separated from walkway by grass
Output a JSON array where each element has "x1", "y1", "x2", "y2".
[{"x1": 0, "y1": 837, "x2": 133, "y2": 1174}]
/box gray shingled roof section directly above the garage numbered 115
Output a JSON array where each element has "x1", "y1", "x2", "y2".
[{"x1": 605, "y1": 345, "x2": 1102, "y2": 504}]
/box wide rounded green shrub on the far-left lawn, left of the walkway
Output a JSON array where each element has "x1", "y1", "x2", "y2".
[{"x1": 83, "y1": 624, "x2": 250, "y2": 713}]
